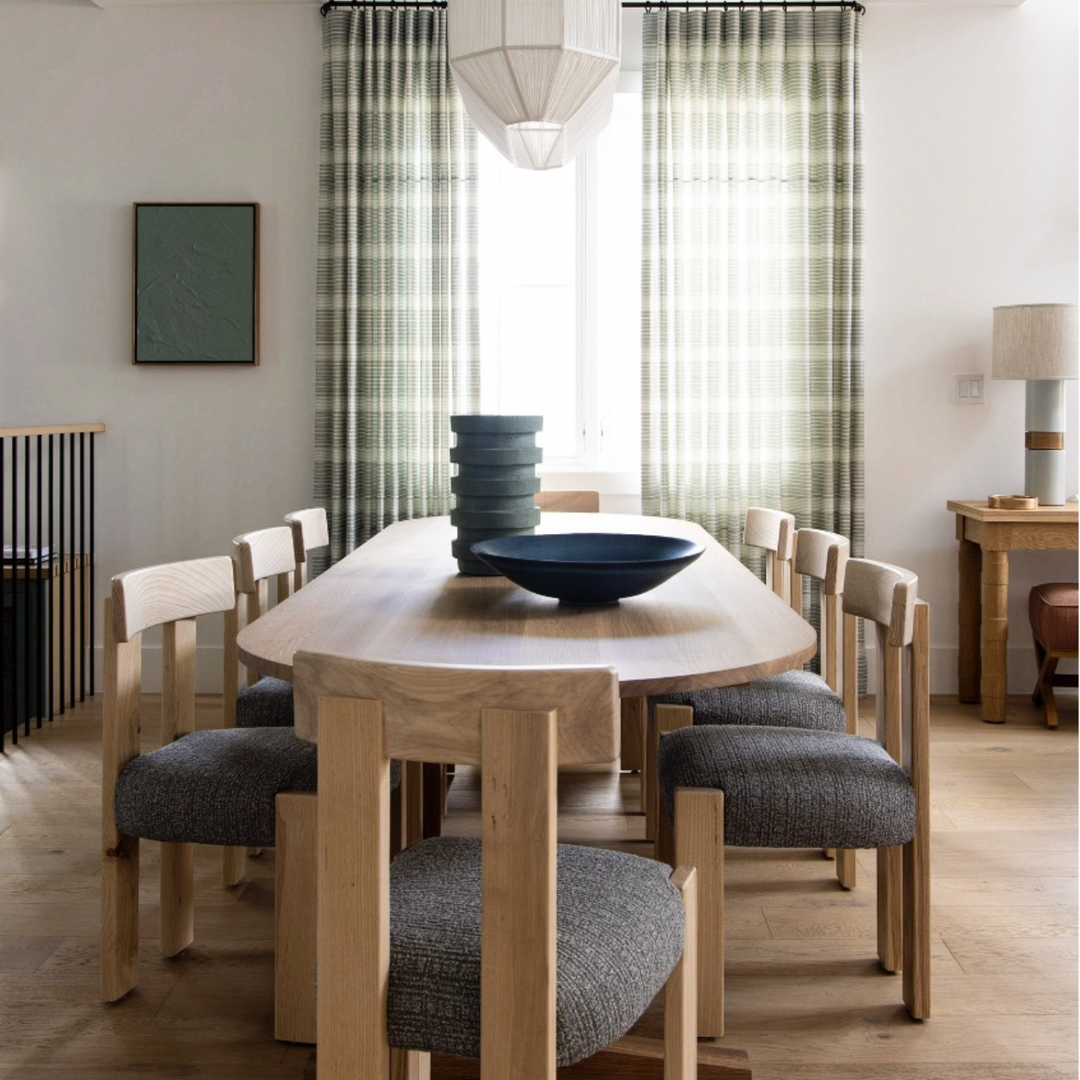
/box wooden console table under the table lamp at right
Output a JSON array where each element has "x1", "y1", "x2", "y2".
[{"x1": 948, "y1": 499, "x2": 1077, "y2": 724}]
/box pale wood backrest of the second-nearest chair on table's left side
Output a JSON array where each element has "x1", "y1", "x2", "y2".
[{"x1": 222, "y1": 525, "x2": 296, "y2": 727}]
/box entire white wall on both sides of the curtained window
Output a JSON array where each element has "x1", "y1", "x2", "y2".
[{"x1": 0, "y1": 0, "x2": 1078, "y2": 692}]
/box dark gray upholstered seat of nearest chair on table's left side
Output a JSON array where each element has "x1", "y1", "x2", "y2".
[{"x1": 114, "y1": 728, "x2": 318, "y2": 848}]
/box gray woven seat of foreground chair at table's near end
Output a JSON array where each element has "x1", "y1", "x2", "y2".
[{"x1": 387, "y1": 837, "x2": 683, "y2": 1066}]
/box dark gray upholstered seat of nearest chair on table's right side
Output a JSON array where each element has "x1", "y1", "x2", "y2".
[{"x1": 657, "y1": 726, "x2": 915, "y2": 848}]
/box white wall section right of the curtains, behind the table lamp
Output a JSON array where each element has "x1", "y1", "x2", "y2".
[{"x1": 863, "y1": 0, "x2": 1080, "y2": 693}]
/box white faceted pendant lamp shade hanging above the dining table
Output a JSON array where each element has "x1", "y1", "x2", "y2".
[{"x1": 446, "y1": 0, "x2": 622, "y2": 168}]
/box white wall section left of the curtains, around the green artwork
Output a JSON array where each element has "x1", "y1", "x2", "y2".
[{"x1": 0, "y1": 0, "x2": 322, "y2": 672}]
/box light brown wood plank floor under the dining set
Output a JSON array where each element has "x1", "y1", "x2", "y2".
[{"x1": 0, "y1": 694, "x2": 1078, "y2": 1080}]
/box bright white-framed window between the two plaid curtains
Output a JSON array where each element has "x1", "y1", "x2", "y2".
[{"x1": 480, "y1": 84, "x2": 642, "y2": 473}]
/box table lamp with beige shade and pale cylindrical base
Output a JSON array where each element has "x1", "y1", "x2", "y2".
[{"x1": 993, "y1": 303, "x2": 1077, "y2": 507}]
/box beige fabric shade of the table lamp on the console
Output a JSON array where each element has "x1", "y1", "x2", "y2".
[{"x1": 993, "y1": 303, "x2": 1077, "y2": 379}]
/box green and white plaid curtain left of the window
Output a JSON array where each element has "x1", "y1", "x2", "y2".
[{"x1": 314, "y1": 9, "x2": 480, "y2": 562}]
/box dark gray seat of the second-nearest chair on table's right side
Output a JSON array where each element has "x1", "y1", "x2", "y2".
[{"x1": 649, "y1": 671, "x2": 848, "y2": 731}]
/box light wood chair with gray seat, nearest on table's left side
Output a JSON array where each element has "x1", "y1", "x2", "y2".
[{"x1": 102, "y1": 555, "x2": 316, "y2": 1001}]
